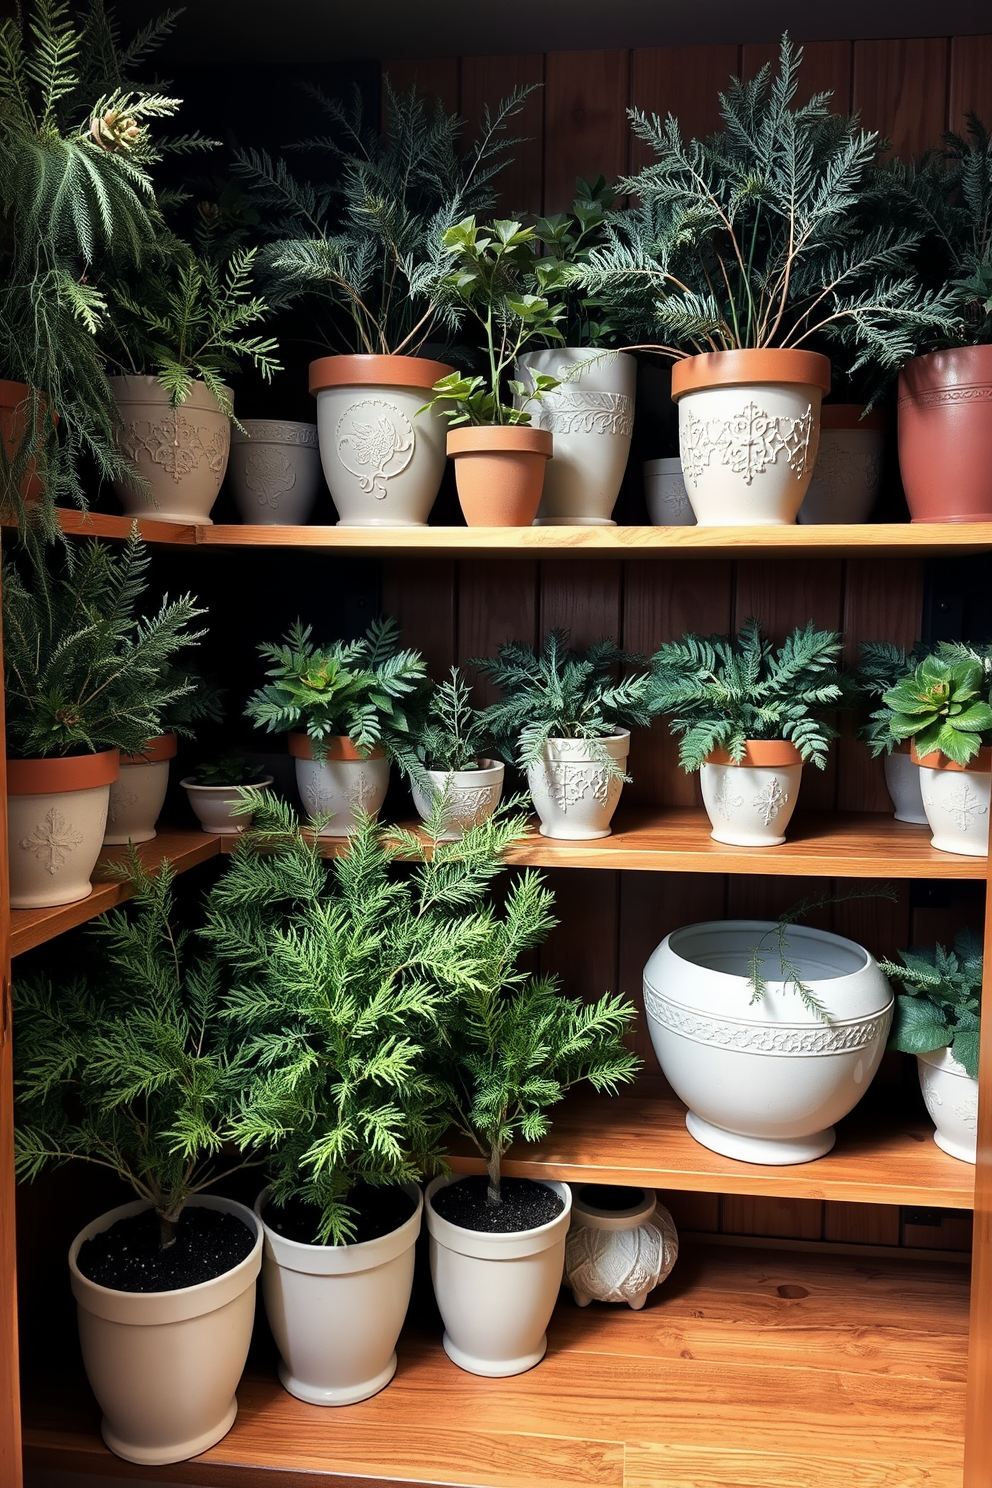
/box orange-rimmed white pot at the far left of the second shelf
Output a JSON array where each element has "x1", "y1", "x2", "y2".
[{"x1": 7, "y1": 748, "x2": 120, "y2": 909}]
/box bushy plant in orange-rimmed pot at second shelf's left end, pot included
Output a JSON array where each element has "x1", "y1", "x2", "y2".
[{"x1": 3, "y1": 530, "x2": 202, "y2": 909}]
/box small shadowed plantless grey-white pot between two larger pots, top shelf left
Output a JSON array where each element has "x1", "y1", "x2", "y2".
[{"x1": 228, "y1": 418, "x2": 321, "y2": 527}]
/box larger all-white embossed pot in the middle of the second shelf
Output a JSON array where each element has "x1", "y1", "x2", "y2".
[{"x1": 526, "y1": 729, "x2": 631, "y2": 842}]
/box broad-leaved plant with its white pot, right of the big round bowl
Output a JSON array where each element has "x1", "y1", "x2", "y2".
[{"x1": 882, "y1": 930, "x2": 982, "y2": 1162}]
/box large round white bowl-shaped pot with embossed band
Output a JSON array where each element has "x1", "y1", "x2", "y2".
[{"x1": 644, "y1": 920, "x2": 892, "y2": 1164}]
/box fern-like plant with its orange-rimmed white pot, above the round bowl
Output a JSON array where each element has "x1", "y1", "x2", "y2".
[{"x1": 651, "y1": 619, "x2": 845, "y2": 847}]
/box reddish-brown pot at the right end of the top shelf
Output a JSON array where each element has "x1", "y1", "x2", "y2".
[{"x1": 898, "y1": 347, "x2": 992, "y2": 522}]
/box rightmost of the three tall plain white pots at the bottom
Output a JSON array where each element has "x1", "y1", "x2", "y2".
[{"x1": 425, "y1": 1177, "x2": 571, "y2": 1379}]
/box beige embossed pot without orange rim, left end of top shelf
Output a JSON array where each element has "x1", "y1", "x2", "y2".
[{"x1": 107, "y1": 376, "x2": 233, "y2": 527}]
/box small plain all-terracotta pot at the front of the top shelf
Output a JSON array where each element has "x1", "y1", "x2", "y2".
[{"x1": 448, "y1": 424, "x2": 555, "y2": 527}]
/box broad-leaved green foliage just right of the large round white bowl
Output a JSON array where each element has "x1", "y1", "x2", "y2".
[{"x1": 880, "y1": 930, "x2": 982, "y2": 1080}]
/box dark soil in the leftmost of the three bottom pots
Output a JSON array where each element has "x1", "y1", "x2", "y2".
[{"x1": 76, "y1": 1208, "x2": 256, "y2": 1292}]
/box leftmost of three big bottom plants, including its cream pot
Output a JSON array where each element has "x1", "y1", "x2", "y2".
[{"x1": 15, "y1": 850, "x2": 262, "y2": 1464}]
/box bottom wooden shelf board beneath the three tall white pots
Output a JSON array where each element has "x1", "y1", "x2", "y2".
[{"x1": 24, "y1": 1242, "x2": 968, "y2": 1488}]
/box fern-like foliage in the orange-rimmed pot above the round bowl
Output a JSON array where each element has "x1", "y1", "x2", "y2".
[{"x1": 650, "y1": 619, "x2": 845, "y2": 774}]
